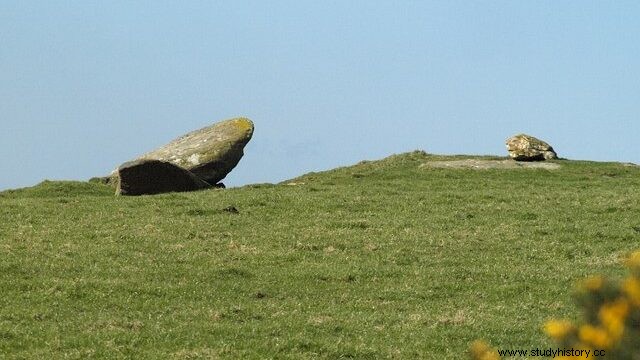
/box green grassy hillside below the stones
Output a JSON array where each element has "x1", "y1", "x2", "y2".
[{"x1": 0, "y1": 151, "x2": 640, "y2": 359}]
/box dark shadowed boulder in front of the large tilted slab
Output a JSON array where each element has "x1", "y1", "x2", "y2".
[{"x1": 116, "y1": 159, "x2": 211, "y2": 195}]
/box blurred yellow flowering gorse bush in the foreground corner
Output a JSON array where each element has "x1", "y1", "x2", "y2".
[{"x1": 470, "y1": 251, "x2": 640, "y2": 360}]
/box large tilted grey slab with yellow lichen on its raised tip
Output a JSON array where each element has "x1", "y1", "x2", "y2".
[{"x1": 137, "y1": 118, "x2": 253, "y2": 184}]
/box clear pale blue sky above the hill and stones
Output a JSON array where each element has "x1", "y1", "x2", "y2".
[{"x1": 0, "y1": 0, "x2": 640, "y2": 189}]
